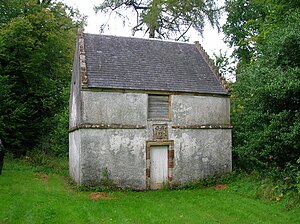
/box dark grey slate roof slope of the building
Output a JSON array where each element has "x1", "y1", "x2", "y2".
[{"x1": 84, "y1": 33, "x2": 227, "y2": 94}]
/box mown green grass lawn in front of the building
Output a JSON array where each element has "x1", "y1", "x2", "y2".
[{"x1": 0, "y1": 161, "x2": 300, "y2": 224}]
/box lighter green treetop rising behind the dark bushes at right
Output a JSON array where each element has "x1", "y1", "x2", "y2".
[{"x1": 223, "y1": 0, "x2": 300, "y2": 63}]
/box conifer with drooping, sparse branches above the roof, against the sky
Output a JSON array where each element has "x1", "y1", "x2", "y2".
[{"x1": 95, "y1": 0, "x2": 220, "y2": 40}]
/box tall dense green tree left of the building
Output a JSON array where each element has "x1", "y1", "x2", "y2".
[{"x1": 0, "y1": 0, "x2": 81, "y2": 156}]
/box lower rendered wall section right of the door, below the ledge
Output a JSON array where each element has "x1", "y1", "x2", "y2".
[{"x1": 171, "y1": 129, "x2": 232, "y2": 184}]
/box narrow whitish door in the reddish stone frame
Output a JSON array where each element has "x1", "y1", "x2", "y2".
[{"x1": 150, "y1": 145, "x2": 168, "y2": 189}]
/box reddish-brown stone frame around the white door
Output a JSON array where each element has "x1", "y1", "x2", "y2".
[{"x1": 146, "y1": 140, "x2": 174, "y2": 190}]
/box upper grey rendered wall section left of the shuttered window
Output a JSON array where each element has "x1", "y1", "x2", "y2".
[{"x1": 82, "y1": 91, "x2": 147, "y2": 126}]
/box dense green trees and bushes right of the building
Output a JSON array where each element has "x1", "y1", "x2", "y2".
[{"x1": 225, "y1": 0, "x2": 300, "y2": 183}]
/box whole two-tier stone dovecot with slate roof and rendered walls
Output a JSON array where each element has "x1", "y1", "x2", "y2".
[{"x1": 69, "y1": 33, "x2": 231, "y2": 189}]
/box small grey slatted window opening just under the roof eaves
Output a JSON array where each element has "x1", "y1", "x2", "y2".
[{"x1": 148, "y1": 95, "x2": 170, "y2": 120}]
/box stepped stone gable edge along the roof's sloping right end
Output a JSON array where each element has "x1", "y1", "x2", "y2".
[{"x1": 195, "y1": 41, "x2": 229, "y2": 92}]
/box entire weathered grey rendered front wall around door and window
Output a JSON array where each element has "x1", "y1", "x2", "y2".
[{"x1": 70, "y1": 91, "x2": 231, "y2": 189}]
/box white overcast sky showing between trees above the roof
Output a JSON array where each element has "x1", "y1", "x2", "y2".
[{"x1": 61, "y1": 0, "x2": 228, "y2": 56}]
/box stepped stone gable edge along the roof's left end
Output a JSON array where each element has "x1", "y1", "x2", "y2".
[{"x1": 78, "y1": 28, "x2": 88, "y2": 86}]
